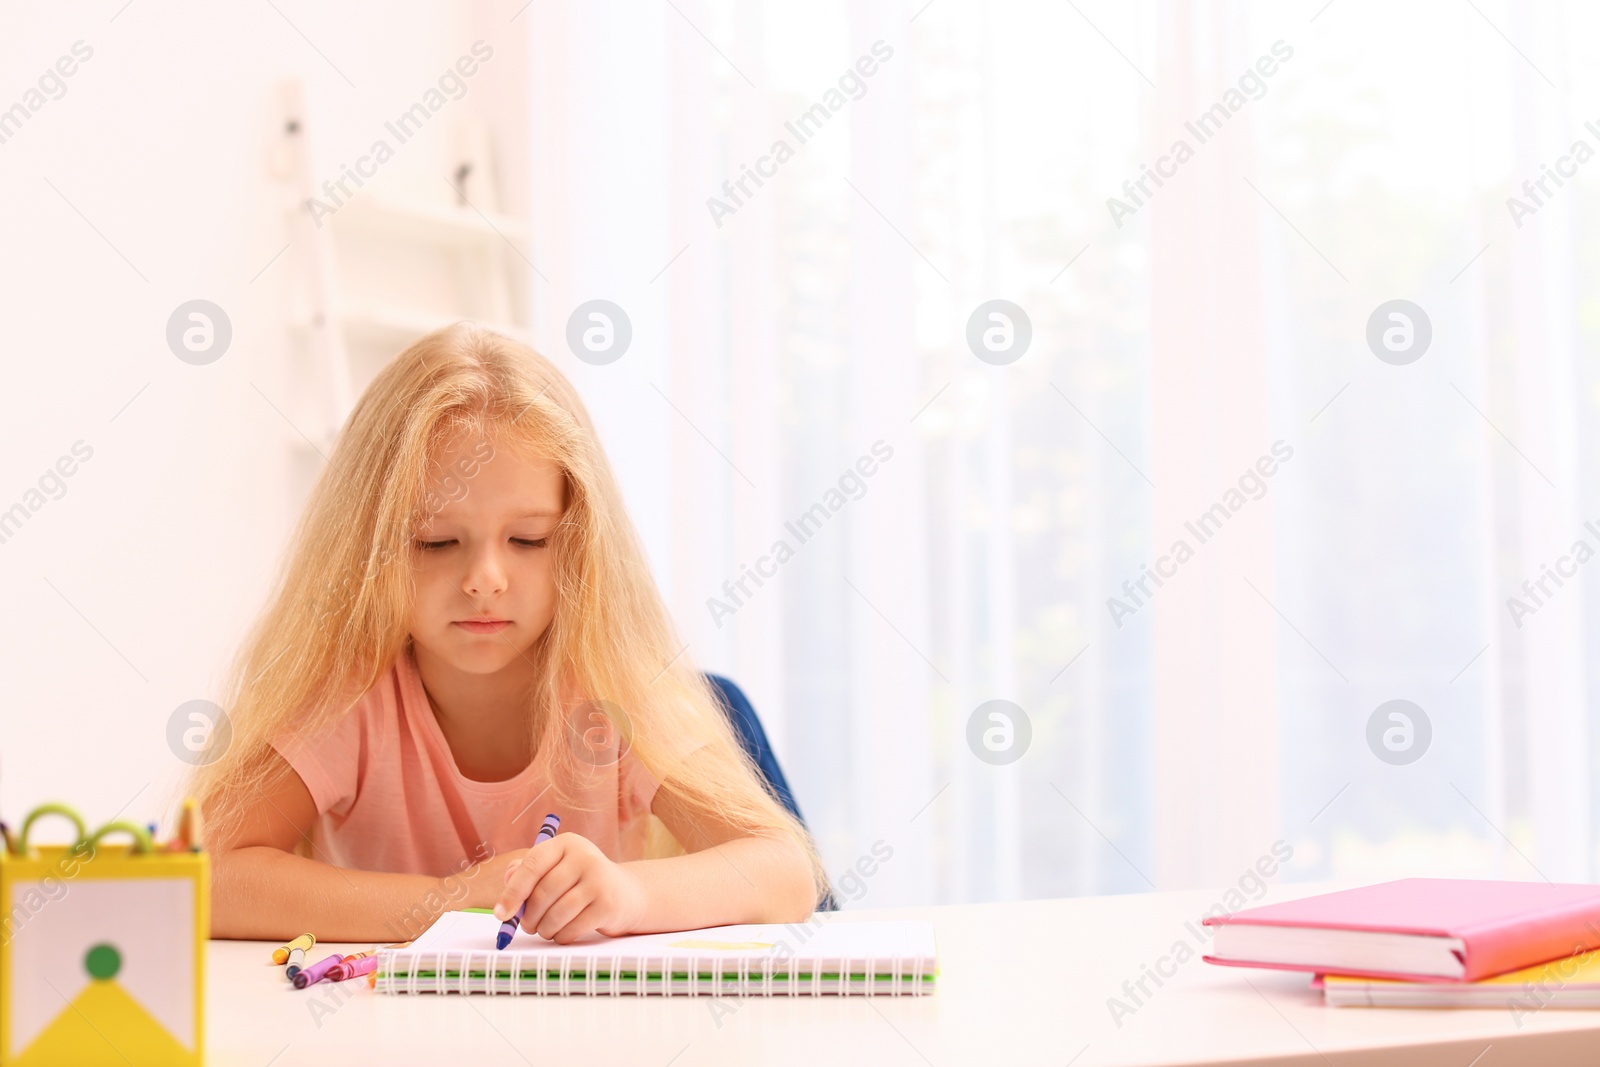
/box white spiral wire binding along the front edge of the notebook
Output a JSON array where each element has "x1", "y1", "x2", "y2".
[{"x1": 376, "y1": 949, "x2": 930, "y2": 997}]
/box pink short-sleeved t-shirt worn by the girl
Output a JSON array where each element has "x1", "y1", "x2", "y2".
[{"x1": 274, "y1": 648, "x2": 659, "y2": 877}]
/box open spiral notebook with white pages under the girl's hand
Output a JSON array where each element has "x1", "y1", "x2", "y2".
[{"x1": 374, "y1": 912, "x2": 939, "y2": 997}]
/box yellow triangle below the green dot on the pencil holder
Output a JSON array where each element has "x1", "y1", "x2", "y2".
[{"x1": 11, "y1": 979, "x2": 200, "y2": 1067}]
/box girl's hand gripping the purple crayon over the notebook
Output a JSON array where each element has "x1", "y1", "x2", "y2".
[{"x1": 494, "y1": 833, "x2": 645, "y2": 944}]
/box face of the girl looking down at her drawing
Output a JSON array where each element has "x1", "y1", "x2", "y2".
[{"x1": 411, "y1": 435, "x2": 566, "y2": 673}]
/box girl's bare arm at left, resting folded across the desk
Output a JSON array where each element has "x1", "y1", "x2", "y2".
[{"x1": 208, "y1": 752, "x2": 522, "y2": 941}]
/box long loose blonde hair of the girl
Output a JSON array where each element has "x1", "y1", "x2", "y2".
[{"x1": 189, "y1": 323, "x2": 827, "y2": 897}]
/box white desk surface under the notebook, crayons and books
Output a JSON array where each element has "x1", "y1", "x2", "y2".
[{"x1": 206, "y1": 886, "x2": 1600, "y2": 1067}]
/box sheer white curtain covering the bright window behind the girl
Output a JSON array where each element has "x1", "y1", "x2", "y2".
[{"x1": 522, "y1": 0, "x2": 1600, "y2": 905}]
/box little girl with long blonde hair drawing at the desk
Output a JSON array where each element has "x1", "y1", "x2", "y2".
[{"x1": 190, "y1": 325, "x2": 827, "y2": 944}]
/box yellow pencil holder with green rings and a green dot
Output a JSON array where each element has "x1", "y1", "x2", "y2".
[{"x1": 0, "y1": 805, "x2": 211, "y2": 1067}]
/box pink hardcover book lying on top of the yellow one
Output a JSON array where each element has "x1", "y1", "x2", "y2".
[{"x1": 1203, "y1": 878, "x2": 1600, "y2": 982}]
